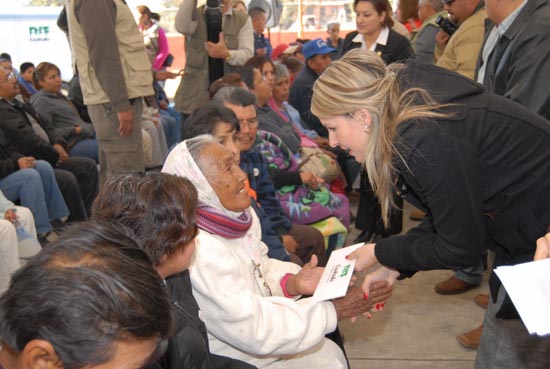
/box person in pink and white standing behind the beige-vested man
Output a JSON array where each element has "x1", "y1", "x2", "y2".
[{"x1": 137, "y1": 5, "x2": 170, "y2": 70}]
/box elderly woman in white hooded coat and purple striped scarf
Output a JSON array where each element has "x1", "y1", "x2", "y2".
[{"x1": 163, "y1": 136, "x2": 391, "y2": 369}]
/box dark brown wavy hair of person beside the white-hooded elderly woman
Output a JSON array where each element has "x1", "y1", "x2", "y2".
[{"x1": 92, "y1": 172, "x2": 198, "y2": 266}]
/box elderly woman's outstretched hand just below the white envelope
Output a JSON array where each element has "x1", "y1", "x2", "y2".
[{"x1": 332, "y1": 281, "x2": 393, "y2": 322}]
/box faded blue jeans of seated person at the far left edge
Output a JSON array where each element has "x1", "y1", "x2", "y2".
[{"x1": 0, "y1": 160, "x2": 69, "y2": 234}]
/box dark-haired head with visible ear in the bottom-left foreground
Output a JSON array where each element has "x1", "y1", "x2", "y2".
[{"x1": 0, "y1": 222, "x2": 172, "y2": 369}]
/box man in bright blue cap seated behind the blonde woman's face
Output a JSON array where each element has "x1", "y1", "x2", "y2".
[{"x1": 288, "y1": 38, "x2": 336, "y2": 137}]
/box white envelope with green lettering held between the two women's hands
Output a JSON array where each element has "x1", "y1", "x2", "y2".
[{"x1": 312, "y1": 243, "x2": 364, "y2": 301}]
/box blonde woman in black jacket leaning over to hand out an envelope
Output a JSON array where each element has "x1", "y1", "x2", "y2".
[{"x1": 311, "y1": 50, "x2": 550, "y2": 368}]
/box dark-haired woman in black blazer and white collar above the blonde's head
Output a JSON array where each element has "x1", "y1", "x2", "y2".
[{"x1": 342, "y1": 0, "x2": 414, "y2": 63}]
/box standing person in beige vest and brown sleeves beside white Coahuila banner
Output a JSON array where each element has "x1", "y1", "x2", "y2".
[{"x1": 66, "y1": 0, "x2": 154, "y2": 183}]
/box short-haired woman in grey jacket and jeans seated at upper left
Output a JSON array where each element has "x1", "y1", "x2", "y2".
[{"x1": 30, "y1": 62, "x2": 99, "y2": 162}]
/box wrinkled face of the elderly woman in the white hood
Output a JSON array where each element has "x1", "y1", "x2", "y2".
[{"x1": 198, "y1": 143, "x2": 250, "y2": 212}]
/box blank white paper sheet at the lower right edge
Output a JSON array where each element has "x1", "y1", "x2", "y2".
[{"x1": 495, "y1": 259, "x2": 550, "y2": 336}]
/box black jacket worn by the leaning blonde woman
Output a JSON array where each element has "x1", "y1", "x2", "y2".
[{"x1": 375, "y1": 60, "x2": 550, "y2": 317}]
